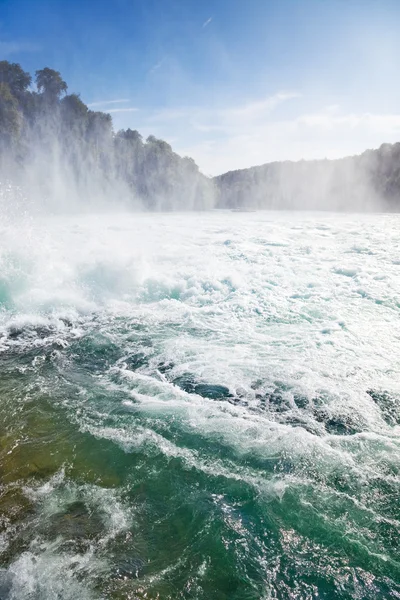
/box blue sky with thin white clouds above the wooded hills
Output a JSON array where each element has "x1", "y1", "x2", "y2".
[{"x1": 0, "y1": 0, "x2": 400, "y2": 174}]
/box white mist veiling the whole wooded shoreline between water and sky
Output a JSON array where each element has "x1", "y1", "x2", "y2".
[{"x1": 0, "y1": 61, "x2": 400, "y2": 214}]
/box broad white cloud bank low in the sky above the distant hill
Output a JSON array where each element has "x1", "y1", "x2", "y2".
[{"x1": 125, "y1": 92, "x2": 400, "y2": 175}]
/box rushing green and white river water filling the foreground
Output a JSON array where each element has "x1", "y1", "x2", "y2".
[{"x1": 0, "y1": 212, "x2": 400, "y2": 600}]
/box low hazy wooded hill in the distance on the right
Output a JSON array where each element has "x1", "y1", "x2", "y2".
[{"x1": 214, "y1": 143, "x2": 400, "y2": 211}]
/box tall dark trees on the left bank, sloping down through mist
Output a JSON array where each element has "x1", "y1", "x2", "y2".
[{"x1": 0, "y1": 61, "x2": 214, "y2": 210}]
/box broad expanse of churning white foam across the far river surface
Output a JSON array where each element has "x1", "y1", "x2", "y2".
[{"x1": 0, "y1": 212, "x2": 400, "y2": 516}]
